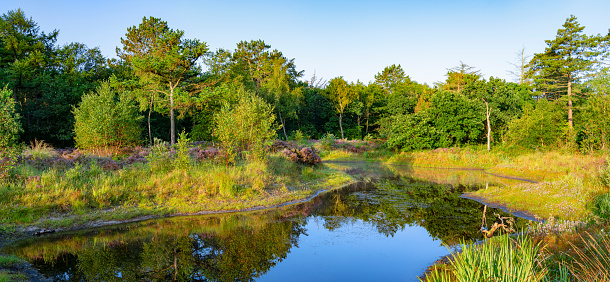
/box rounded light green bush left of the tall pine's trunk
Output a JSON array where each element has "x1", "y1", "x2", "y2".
[{"x1": 73, "y1": 82, "x2": 142, "y2": 149}]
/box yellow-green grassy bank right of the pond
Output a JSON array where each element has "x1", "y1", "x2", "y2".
[{"x1": 322, "y1": 144, "x2": 610, "y2": 220}]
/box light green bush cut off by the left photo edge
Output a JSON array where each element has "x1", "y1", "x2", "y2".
[{"x1": 0, "y1": 87, "x2": 22, "y2": 149}]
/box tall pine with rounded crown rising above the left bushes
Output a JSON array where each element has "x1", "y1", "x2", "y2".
[{"x1": 117, "y1": 17, "x2": 208, "y2": 145}]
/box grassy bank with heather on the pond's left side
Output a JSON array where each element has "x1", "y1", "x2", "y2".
[{"x1": 0, "y1": 150, "x2": 353, "y2": 227}]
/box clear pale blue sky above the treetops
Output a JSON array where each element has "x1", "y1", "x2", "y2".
[{"x1": 0, "y1": 0, "x2": 610, "y2": 85}]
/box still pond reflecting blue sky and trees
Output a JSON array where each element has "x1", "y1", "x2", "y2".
[{"x1": 2, "y1": 163, "x2": 528, "y2": 281}]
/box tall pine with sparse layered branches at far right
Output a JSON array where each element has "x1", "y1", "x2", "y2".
[{"x1": 528, "y1": 15, "x2": 609, "y2": 132}]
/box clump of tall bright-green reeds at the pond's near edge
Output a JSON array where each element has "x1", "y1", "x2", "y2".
[{"x1": 425, "y1": 235, "x2": 547, "y2": 282}]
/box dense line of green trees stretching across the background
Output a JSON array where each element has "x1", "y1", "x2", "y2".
[{"x1": 0, "y1": 9, "x2": 610, "y2": 151}]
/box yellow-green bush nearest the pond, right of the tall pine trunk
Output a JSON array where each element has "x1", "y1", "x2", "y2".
[{"x1": 214, "y1": 93, "x2": 279, "y2": 163}]
